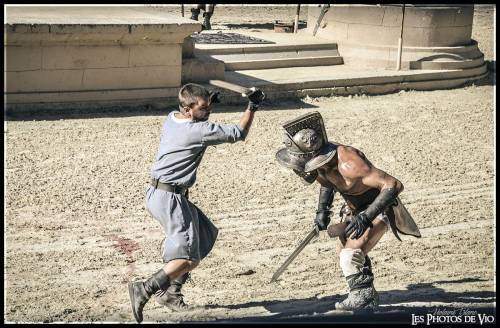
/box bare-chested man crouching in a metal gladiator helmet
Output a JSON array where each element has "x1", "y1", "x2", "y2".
[{"x1": 276, "y1": 112, "x2": 420, "y2": 311}]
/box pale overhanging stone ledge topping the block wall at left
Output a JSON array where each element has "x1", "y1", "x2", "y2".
[{"x1": 4, "y1": 5, "x2": 201, "y2": 45}]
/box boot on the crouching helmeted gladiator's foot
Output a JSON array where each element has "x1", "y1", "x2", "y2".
[{"x1": 335, "y1": 256, "x2": 378, "y2": 311}]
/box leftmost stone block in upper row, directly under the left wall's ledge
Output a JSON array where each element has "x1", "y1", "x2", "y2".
[{"x1": 4, "y1": 46, "x2": 42, "y2": 72}]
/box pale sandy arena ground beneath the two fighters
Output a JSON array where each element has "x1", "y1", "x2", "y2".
[{"x1": 4, "y1": 7, "x2": 496, "y2": 323}]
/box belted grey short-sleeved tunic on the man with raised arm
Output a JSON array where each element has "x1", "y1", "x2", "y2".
[{"x1": 145, "y1": 112, "x2": 246, "y2": 263}]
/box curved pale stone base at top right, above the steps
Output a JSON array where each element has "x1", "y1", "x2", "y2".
[{"x1": 307, "y1": 5, "x2": 482, "y2": 69}]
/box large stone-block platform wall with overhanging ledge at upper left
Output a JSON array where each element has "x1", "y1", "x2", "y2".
[{"x1": 4, "y1": 7, "x2": 201, "y2": 110}]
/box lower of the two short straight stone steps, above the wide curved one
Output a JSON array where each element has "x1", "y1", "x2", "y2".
[{"x1": 224, "y1": 56, "x2": 344, "y2": 71}]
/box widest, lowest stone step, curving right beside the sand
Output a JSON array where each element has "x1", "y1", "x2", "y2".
[{"x1": 207, "y1": 63, "x2": 488, "y2": 104}]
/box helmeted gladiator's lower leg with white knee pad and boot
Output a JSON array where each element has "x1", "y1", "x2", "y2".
[{"x1": 335, "y1": 248, "x2": 378, "y2": 311}]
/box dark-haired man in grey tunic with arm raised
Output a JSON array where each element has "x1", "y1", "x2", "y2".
[{"x1": 128, "y1": 83, "x2": 264, "y2": 322}]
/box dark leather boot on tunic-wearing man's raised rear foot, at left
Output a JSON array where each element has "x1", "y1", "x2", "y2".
[{"x1": 128, "y1": 269, "x2": 170, "y2": 323}]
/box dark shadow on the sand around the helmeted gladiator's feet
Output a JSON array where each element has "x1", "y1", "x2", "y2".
[{"x1": 200, "y1": 278, "x2": 496, "y2": 324}]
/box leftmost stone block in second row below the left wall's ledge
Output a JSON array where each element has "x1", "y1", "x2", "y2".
[{"x1": 6, "y1": 70, "x2": 83, "y2": 92}]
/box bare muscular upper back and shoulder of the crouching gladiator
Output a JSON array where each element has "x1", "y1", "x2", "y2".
[{"x1": 317, "y1": 145, "x2": 403, "y2": 195}]
